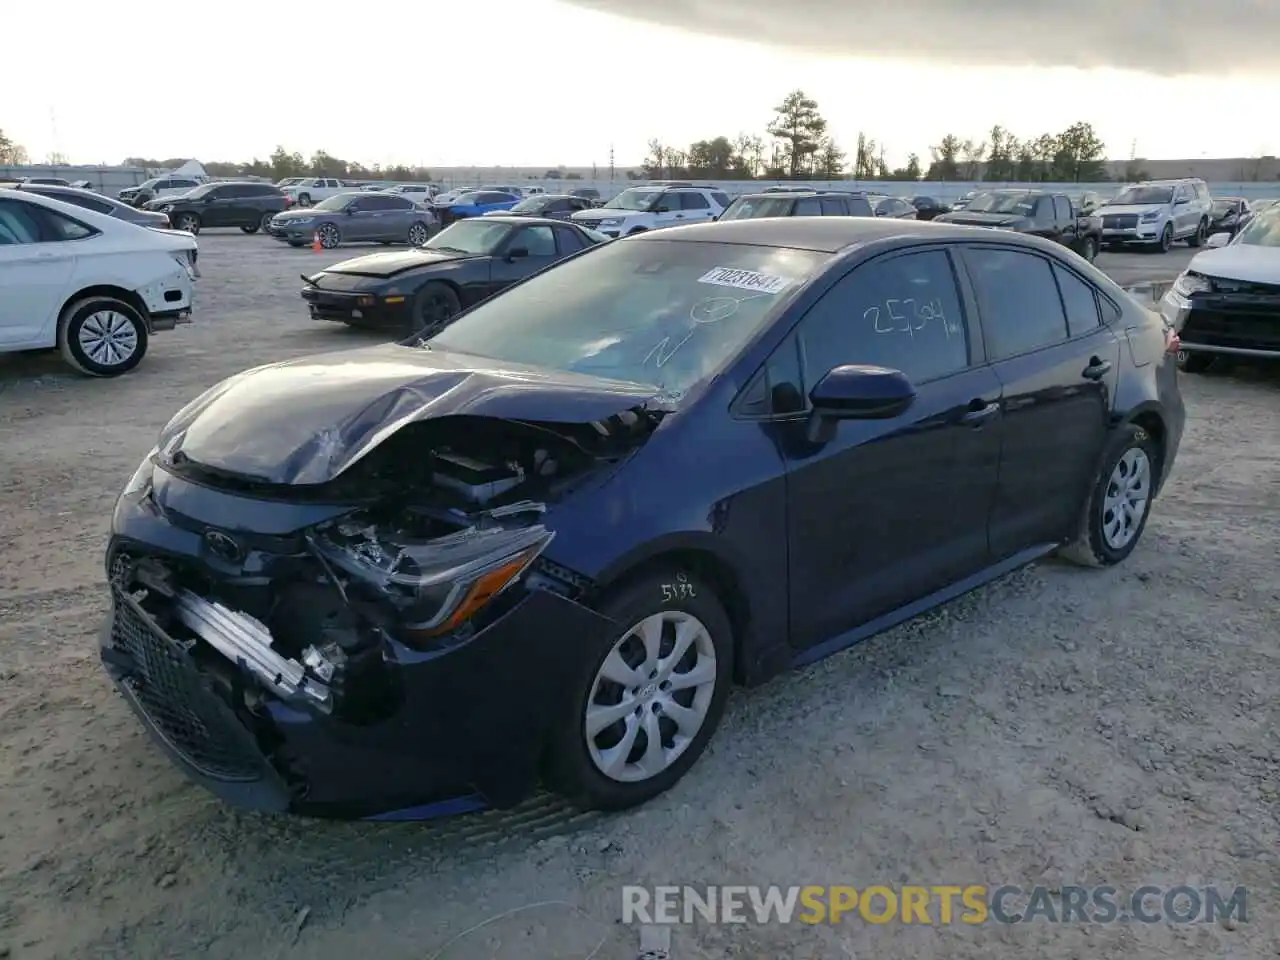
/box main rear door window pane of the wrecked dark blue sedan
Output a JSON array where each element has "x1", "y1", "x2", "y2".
[{"x1": 964, "y1": 247, "x2": 1066, "y2": 360}]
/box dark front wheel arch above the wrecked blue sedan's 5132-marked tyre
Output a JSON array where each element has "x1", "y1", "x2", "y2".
[{"x1": 595, "y1": 532, "x2": 753, "y2": 684}]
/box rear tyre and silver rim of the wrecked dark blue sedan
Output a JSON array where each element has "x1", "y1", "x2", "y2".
[{"x1": 1061, "y1": 424, "x2": 1161, "y2": 567}]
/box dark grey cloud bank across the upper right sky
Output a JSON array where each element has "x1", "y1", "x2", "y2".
[{"x1": 568, "y1": 0, "x2": 1280, "y2": 75}]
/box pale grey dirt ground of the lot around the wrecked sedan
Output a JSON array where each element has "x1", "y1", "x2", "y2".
[{"x1": 0, "y1": 233, "x2": 1280, "y2": 960}]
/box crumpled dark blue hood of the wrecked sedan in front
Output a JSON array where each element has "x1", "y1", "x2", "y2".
[{"x1": 159, "y1": 343, "x2": 669, "y2": 484}]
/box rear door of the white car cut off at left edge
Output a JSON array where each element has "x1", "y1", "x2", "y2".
[{"x1": 0, "y1": 200, "x2": 81, "y2": 349}]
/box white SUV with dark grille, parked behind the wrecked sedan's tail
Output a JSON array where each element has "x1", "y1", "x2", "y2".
[{"x1": 1093, "y1": 179, "x2": 1213, "y2": 251}]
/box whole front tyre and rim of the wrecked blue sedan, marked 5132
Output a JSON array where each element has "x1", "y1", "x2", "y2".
[{"x1": 549, "y1": 566, "x2": 733, "y2": 810}]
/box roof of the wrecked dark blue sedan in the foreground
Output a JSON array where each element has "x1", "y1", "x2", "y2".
[{"x1": 640, "y1": 216, "x2": 1021, "y2": 253}]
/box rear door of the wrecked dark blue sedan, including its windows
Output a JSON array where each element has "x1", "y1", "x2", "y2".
[{"x1": 963, "y1": 243, "x2": 1120, "y2": 559}]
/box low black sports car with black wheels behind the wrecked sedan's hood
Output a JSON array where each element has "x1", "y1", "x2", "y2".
[{"x1": 302, "y1": 216, "x2": 609, "y2": 333}]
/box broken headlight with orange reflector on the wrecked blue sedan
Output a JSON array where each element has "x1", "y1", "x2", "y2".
[{"x1": 308, "y1": 515, "x2": 556, "y2": 643}]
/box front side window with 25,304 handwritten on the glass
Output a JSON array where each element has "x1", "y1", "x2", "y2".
[{"x1": 799, "y1": 250, "x2": 962, "y2": 389}]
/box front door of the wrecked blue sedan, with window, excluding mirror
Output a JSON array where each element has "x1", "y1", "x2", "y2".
[{"x1": 778, "y1": 247, "x2": 1002, "y2": 646}]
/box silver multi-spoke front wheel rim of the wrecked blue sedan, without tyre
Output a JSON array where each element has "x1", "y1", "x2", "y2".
[{"x1": 582, "y1": 609, "x2": 717, "y2": 783}]
